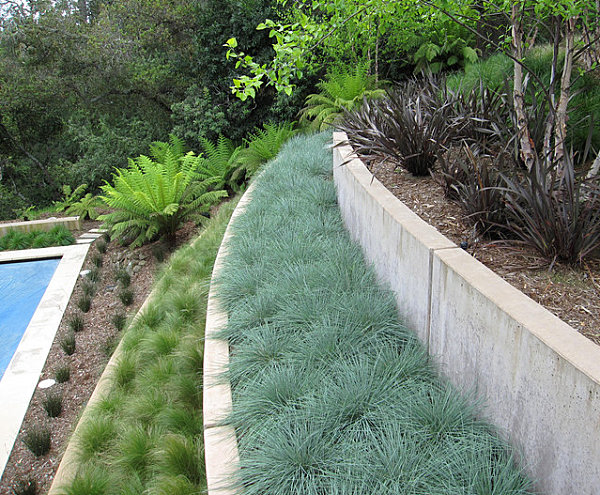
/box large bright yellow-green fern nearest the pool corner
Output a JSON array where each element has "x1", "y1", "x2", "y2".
[{"x1": 98, "y1": 143, "x2": 227, "y2": 247}]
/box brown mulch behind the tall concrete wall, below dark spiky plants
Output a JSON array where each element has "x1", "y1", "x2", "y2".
[{"x1": 373, "y1": 161, "x2": 600, "y2": 344}]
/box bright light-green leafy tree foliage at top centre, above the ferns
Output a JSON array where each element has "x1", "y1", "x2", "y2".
[{"x1": 225, "y1": 0, "x2": 477, "y2": 100}]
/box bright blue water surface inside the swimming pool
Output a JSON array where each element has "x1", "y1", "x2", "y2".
[{"x1": 0, "y1": 258, "x2": 60, "y2": 378}]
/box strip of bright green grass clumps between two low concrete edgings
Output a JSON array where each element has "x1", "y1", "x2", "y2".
[{"x1": 54, "y1": 202, "x2": 235, "y2": 495}]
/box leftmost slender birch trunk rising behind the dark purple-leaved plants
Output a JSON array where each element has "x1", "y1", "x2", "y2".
[{"x1": 511, "y1": 3, "x2": 535, "y2": 170}]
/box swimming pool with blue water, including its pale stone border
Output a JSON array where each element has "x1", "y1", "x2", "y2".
[{"x1": 0, "y1": 244, "x2": 90, "y2": 476}]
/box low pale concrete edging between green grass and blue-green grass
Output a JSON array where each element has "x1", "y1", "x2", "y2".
[{"x1": 202, "y1": 182, "x2": 255, "y2": 495}]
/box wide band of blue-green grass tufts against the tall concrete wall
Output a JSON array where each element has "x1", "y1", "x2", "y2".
[{"x1": 217, "y1": 135, "x2": 530, "y2": 495}]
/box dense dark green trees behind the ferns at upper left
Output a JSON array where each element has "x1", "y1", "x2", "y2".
[{"x1": 0, "y1": 0, "x2": 311, "y2": 218}]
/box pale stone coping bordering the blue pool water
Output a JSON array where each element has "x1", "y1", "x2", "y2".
[{"x1": 0, "y1": 242, "x2": 90, "y2": 477}]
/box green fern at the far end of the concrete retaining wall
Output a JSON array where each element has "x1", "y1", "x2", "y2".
[{"x1": 300, "y1": 64, "x2": 385, "y2": 131}]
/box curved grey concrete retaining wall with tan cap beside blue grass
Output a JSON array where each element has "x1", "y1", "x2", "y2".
[{"x1": 333, "y1": 133, "x2": 600, "y2": 495}]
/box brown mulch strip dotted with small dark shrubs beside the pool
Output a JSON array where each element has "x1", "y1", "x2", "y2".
[{"x1": 0, "y1": 221, "x2": 202, "y2": 495}]
